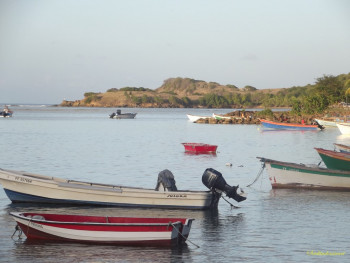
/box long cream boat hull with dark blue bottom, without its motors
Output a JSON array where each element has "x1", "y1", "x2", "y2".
[{"x1": 0, "y1": 170, "x2": 220, "y2": 210}]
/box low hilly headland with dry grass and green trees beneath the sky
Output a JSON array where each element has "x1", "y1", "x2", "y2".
[{"x1": 60, "y1": 73, "x2": 350, "y2": 121}]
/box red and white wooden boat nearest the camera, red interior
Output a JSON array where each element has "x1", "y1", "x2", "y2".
[{"x1": 10, "y1": 212, "x2": 194, "y2": 246}]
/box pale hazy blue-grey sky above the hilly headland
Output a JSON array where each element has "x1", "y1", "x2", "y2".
[{"x1": 0, "y1": 0, "x2": 350, "y2": 104}]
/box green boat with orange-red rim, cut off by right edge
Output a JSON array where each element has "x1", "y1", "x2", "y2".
[{"x1": 315, "y1": 148, "x2": 350, "y2": 171}]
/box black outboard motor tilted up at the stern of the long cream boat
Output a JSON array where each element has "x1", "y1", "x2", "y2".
[{"x1": 202, "y1": 168, "x2": 247, "y2": 202}]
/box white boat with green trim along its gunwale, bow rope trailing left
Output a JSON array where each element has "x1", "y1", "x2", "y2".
[{"x1": 257, "y1": 157, "x2": 350, "y2": 191}]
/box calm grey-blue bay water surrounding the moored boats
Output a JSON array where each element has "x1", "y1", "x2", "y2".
[{"x1": 0, "y1": 106, "x2": 350, "y2": 262}]
